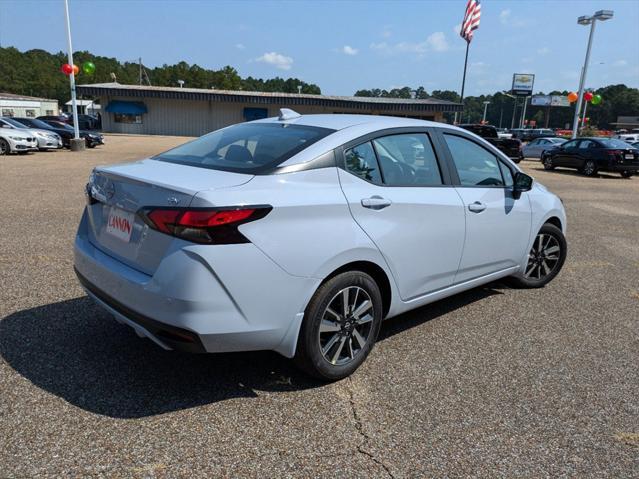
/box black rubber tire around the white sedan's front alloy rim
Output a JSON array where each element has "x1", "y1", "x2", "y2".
[{"x1": 509, "y1": 223, "x2": 568, "y2": 288}]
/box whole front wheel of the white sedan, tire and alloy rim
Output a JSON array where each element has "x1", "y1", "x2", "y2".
[{"x1": 511, "y1": 223, "x2": 568, "y2": 288}]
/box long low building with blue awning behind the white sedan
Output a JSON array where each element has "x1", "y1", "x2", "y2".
[{"x1": 77, "y1": 83, "x2": 462, "y2": 136}]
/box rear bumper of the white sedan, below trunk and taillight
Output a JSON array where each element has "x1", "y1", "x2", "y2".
[{"x1": 74, "y1": 210, "x2": 319, "y2": 356}]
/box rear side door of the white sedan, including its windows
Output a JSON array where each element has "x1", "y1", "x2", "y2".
[{"x1": 339, "y1": 131, "x2": 465, "y2": 300}]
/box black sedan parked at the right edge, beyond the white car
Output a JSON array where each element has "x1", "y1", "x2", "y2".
[{"x1": 541, "y1": 138, "x2": 639, "y2": 178}]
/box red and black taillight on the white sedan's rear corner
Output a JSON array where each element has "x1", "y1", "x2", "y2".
[{"x1": 139, "y1": 205, "x2": 273, "y2": 244}]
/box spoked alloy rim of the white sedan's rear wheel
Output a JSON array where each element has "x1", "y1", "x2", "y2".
[{"x1": 318, "y1": 286, "x2": 374, "y2": 366}]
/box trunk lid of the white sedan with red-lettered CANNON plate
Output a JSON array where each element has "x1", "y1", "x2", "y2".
[{"x1": 87, "y1": 159, "x2": 253, "y2": 275}]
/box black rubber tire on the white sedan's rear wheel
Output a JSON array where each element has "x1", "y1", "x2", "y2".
[{"x1": 294, "y1": 271, "x2": 382, "y2": 381}]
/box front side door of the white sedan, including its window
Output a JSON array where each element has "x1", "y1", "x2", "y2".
[{"x1": 442, "y1": 131, "x2": 532, "y2": 283}]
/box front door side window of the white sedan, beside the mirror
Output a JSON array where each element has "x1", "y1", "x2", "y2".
[{"x1": 444, "y1": 134, "x2": 504, "y2": 186}]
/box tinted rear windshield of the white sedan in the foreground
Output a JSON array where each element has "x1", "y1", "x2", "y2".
[{"x1": 153, "y1": 123, "x2": 335, "y2": 174}]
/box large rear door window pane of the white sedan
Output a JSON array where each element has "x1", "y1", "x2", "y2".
[{"x1": 373, "y1": 133, "x2": 442, "y2": 186}]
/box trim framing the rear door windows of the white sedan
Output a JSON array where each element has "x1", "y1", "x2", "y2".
[{"x1": 335, "y1": 127, "x2": 459, "y2": 188}]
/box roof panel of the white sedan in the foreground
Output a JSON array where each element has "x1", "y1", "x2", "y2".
[{"x1": 252, "y1": 114, "x2": 443, "y2": 131}]
